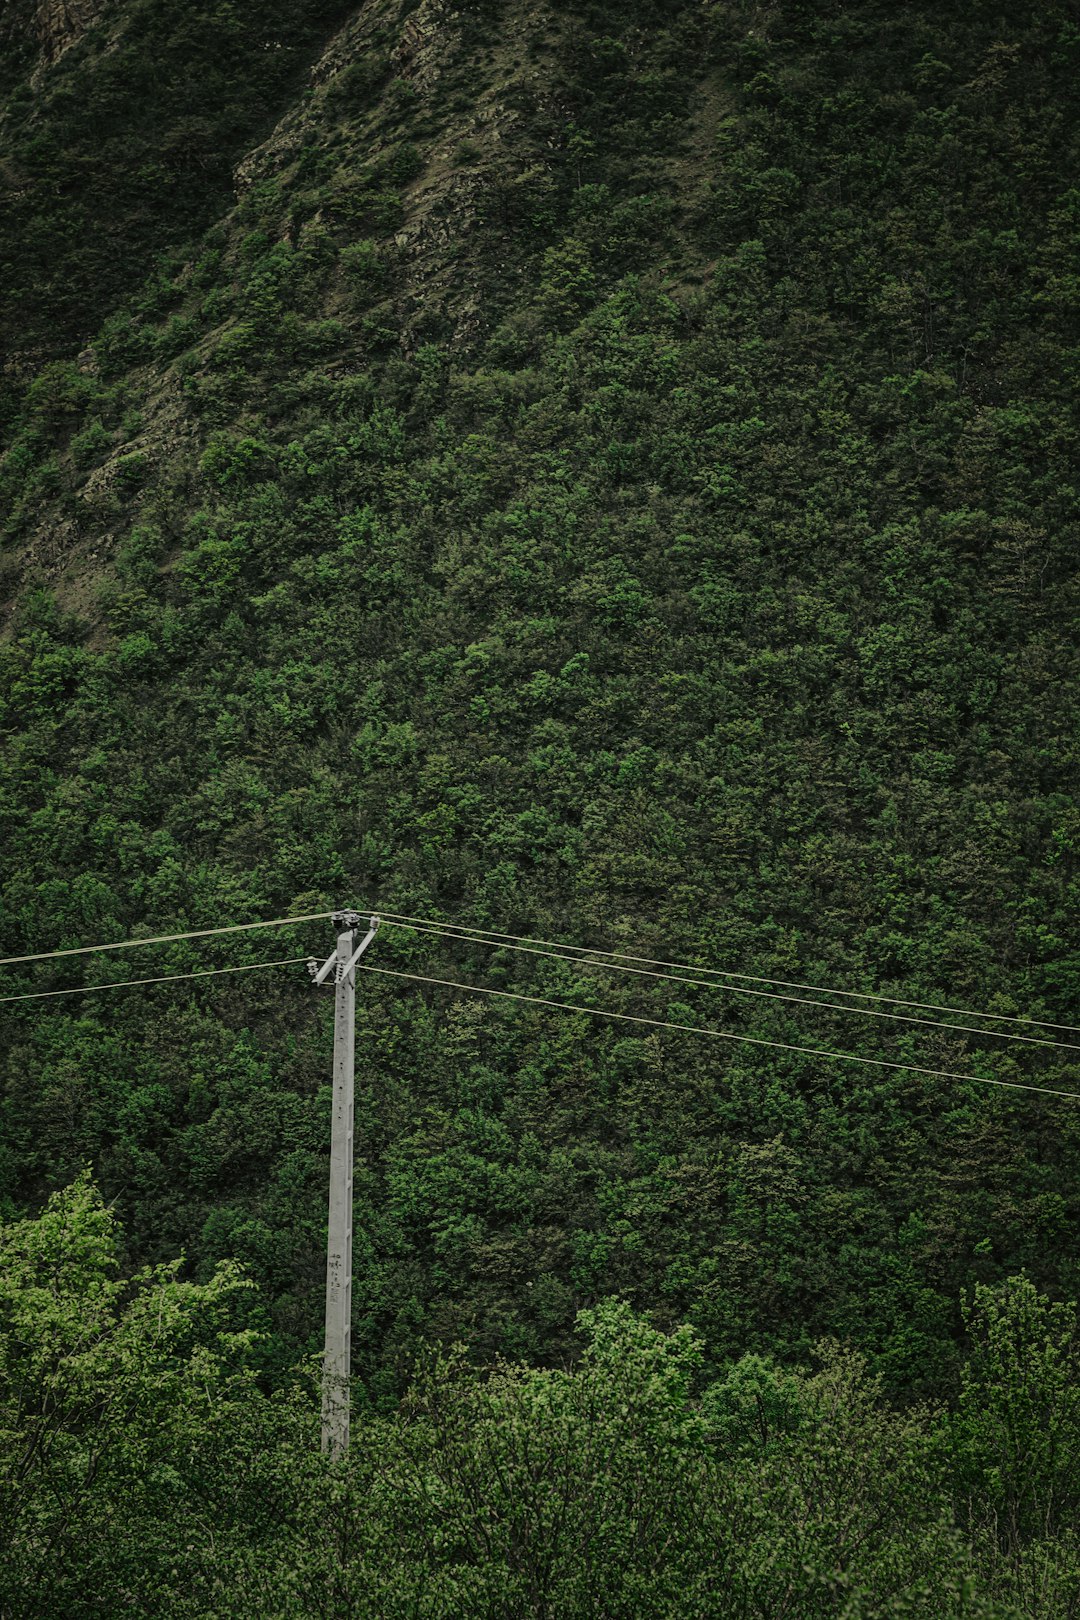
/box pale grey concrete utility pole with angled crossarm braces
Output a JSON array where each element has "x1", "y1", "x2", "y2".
[{"x1": 308, "y1": 910, "x2": 379, "y2": 1458}]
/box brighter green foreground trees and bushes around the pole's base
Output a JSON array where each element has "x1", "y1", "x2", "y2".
[{"x1": 8, "y1": 1181, "x2": 1080, "y2": 1620}]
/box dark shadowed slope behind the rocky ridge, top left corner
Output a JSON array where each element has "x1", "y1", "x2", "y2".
[{"x1": 0, "y1": 0, "x2": 345, "y2": 428}]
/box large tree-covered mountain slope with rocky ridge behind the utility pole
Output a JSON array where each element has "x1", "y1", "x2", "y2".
[{"x1": 0, "y1": 0, "x2": 1080, "y2": 1396}]
